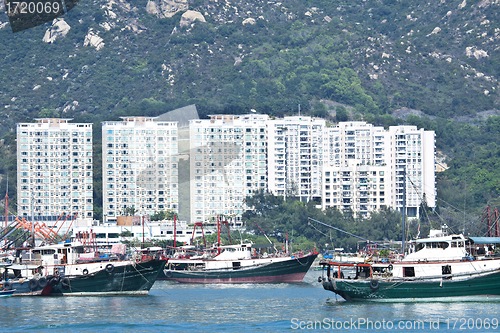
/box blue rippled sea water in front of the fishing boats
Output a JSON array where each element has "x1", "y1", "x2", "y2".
[{"x1": 0, "y1": 271, "x2": 500, "y2": 332}]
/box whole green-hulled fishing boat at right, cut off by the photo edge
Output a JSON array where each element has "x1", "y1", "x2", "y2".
[{"x1": 319, "y1": 234, "x2": 500, "y2": 302}]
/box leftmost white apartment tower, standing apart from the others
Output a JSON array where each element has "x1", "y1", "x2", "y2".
[{"x1": 17, "y1": 118, "x2": 93, "y2": 225}]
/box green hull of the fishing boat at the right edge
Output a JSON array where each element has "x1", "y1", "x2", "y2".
[{"x1": 323, "y1": 271, "x2": 500, "y2": 302}]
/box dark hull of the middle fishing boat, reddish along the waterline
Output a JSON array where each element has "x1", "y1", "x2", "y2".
[{"x1": 159, "y1": 254, "x2": 317, "y2": 283}]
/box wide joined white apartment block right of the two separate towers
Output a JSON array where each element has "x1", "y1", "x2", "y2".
[{"x1": 190, "y1": 115, "x2": 436, "y2": 221}]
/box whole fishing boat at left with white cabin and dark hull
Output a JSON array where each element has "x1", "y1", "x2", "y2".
[{"x1": 3, "y1": 241, "x2": 166, "y2": 296}]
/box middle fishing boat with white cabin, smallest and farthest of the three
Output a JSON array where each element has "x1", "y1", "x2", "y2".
[{"x1": 159, "y1": 243, "x2": 318, "y2": 283}]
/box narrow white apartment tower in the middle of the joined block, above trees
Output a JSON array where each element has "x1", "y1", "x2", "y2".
[{"x1": 267, "y1": 116, "x2": 326, "y2": 201}]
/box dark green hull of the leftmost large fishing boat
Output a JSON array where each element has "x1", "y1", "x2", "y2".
[{"x1": 42, "y1": 260, "x2": 166, "y2": 296}]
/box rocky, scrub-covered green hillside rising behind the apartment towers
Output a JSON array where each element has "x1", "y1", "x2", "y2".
[{"x1": 0, "y1": 0, "x2": 500, "y2": 124}]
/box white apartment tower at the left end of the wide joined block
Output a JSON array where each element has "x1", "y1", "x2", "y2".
[{"x1": 189, "y1": 114, "x2": 269, "y2": 224}]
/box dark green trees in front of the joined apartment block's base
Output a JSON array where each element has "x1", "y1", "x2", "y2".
[{"x1": 243, "y1": 188, "x2": 410, "y2": 252}]
